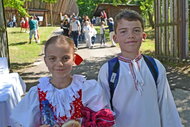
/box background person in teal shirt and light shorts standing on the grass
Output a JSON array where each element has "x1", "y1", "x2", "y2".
[{"x1": 29, "y1": 16, "x2": 38, "y2": 44}]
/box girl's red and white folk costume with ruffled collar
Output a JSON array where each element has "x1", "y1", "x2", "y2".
[{"x1": 11, "y1": 75, "x2": 114, "y2": 127}]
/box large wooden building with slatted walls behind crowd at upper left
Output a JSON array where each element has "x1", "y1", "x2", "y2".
[{"x1": 5, "y1": 0, "x2": 79, "y2": 26}]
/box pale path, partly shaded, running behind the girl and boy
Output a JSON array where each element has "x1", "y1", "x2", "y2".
[{"x1": 20, "y1": 28, "x2": 190, "y2": 127}]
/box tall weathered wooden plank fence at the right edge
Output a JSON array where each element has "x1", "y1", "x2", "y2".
[{"x1": 154, "y1": 0, "x2": 189, "y2": 61}]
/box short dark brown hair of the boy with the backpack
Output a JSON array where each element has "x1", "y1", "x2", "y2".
[{"x1": 114, "y1": 9, "x2": 144, "y2": 32}]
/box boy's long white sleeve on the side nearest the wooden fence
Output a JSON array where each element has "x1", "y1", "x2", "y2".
[{"x1": 156, "y1": 60, "x2": 182, "y2": 127}]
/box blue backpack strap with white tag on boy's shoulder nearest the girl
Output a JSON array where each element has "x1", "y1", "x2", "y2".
[{"x1": 108, "y1": 57, "x2": 119, "y2": 109}]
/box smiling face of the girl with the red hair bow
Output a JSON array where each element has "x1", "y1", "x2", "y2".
[{"x1": 44, "y1": 43, "x2": 74, "y2": 78}]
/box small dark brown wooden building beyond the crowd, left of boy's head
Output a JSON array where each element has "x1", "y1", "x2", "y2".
[{"x1": 94, "y1": 3, "x2": 141, "y2": 18}]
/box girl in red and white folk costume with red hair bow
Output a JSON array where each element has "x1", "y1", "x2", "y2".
[{"x1": 11, "y1": 35, "x2": 114, "y2": 127}]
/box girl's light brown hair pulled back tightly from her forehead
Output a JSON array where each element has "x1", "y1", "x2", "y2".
[{"x1": 44, "y1": 35, "x2": 74, "y2": 56}]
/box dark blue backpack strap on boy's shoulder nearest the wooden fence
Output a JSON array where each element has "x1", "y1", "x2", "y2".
[{"x1": 142, "y1": 55, "x2": 158, "y2": 87}]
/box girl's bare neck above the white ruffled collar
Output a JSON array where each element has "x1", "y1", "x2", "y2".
[{"x1": 50, "y1": 76, "x2": 72, "y2": 89}]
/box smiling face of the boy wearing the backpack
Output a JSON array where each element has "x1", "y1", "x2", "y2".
[{"x1": 114, "y1": 19, "x2": 146, "y2": 55}]
